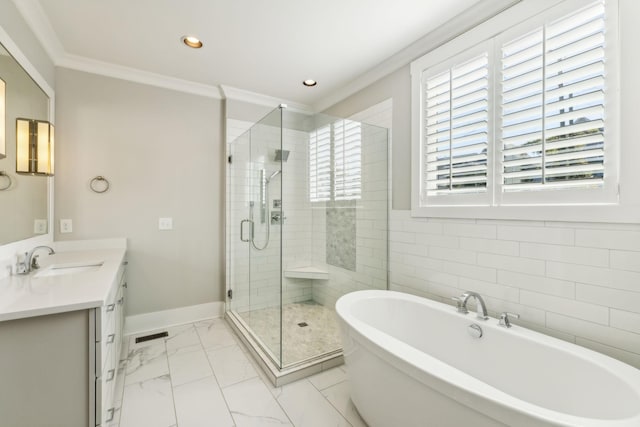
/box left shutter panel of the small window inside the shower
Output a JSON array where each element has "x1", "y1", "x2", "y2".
[{"x1": 309, "y1": 125, "x2": 331, "y2": 202}]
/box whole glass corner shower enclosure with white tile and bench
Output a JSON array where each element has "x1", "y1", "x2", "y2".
[{"x1": 226, "y1": 106, "x2": 389, "y2": 382}]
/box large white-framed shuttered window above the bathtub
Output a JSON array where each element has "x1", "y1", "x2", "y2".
[{"x1": 412, "y1": 0, "x2": 619, "y2": 221}]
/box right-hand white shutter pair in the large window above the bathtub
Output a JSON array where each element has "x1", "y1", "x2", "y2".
[{"x1": 501, "y1": 2, "x2": 605, "y2": 191}]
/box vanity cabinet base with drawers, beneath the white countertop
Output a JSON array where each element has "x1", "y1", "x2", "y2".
[{"x1": 0, "y1": 258, "x2": 127, "y2": 427}]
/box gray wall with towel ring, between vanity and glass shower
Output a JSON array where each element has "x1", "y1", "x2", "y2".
[{"x1": 55, "y1": 68, "x2": 224, "y2": 315}]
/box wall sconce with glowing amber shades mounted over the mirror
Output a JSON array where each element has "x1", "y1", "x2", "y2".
[{"x1": 16, "y1": 119, "x2": 54, "y2": 176}]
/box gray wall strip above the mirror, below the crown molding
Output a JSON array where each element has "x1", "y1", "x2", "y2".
[{"x1": 0, "y1": 0, "x2": 56, "y2": 87}]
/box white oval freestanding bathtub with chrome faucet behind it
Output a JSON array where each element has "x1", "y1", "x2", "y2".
[{"x1": 336, "y1": 291, "x2": 640, "y2": 427}]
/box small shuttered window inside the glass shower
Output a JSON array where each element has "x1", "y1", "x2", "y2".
[{"x1": 309, "y1": 120, "x2": 362, "y2": 202}]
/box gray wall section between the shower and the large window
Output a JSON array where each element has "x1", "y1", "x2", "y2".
[{"x1": 324, "y1": 65, "x2": 411, "y2": 209}]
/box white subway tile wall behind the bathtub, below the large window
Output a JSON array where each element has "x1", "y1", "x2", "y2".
[{"x1": 389, "y1": 210, "x2": 640, "y2": 368}]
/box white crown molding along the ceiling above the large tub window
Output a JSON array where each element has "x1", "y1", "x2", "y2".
[{"x1": 312, "y1": 0, "x2": 523, "y2": 111}]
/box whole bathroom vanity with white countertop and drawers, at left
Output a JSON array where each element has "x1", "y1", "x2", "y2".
[{"x1": 0, "y1": 239, "x2": 127, "y2": 427}]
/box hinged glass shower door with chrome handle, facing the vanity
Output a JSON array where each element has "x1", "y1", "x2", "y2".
[{"x1": 227, "y1": 108, "x2": 282, "y2": 366}]
